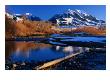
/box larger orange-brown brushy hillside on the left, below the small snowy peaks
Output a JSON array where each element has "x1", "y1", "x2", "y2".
[{"x1": 5, "y1": 16, "x2": 58, "y2": 38}]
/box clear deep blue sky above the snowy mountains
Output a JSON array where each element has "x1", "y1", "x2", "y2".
[{"x1": 6, "y1": 5, "x2": 106, "y2": 20}]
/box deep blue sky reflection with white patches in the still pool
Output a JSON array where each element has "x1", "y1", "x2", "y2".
[{"x1": 10, "y1": 46, "x2": 88, "y2": 62}]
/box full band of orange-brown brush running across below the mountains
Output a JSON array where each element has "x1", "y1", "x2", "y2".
[{"x1": 5, "y1": 16, "x2": 106, "y2": 38}]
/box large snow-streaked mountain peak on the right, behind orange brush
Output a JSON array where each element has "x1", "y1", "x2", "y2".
[{"x1": 49, "y1": 9, "x2": 105, "y2": 26}]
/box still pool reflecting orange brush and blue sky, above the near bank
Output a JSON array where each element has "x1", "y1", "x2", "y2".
[{"x1": 6, "y1": 41, "x2": 89, "y2": 63}]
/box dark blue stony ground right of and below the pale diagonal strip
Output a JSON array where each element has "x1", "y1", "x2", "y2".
[{"x1": 39, "y1": 51, "x2": 106, "y2": 70}]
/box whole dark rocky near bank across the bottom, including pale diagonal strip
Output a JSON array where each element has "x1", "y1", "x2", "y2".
[{"x1": 5, "y1": 49, "x2": 106, "y2": 70}]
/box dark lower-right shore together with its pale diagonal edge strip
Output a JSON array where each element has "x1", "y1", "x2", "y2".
[{"x1": 36, "y1": 52, "x2": 106, "y2": 70}]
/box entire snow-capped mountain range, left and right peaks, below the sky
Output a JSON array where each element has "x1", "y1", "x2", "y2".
[{"x1": 6, "y1": 9, "x2": 106, "y2": 27}]
